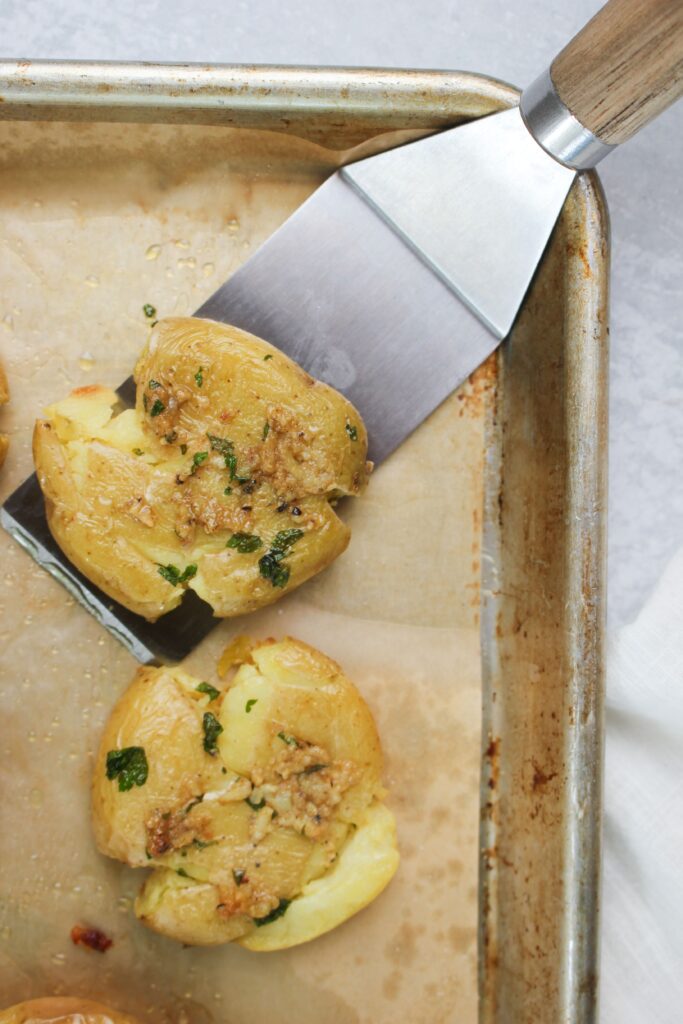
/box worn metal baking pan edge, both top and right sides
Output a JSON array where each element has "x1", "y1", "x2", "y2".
[{"x1": 0, "y1": 60, "x2": 608, "y2": 1024}]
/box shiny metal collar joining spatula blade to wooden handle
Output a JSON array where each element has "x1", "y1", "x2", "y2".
[{"x1": 519, "y1": 68, "x2": 616, "y2": 171}]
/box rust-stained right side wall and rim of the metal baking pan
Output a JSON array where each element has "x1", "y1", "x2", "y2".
[{"x1": 479, "y1": 174, "x2": 609, "y2": 1024}]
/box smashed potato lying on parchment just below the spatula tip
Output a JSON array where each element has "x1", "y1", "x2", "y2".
[{"x1": 92, "y1": 639, "x2": 398, "y2": 950}]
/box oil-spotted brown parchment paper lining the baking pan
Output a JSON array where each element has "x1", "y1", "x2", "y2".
[{"x1": 0, "y1": 116, "x2": 496, "y2": 1024}]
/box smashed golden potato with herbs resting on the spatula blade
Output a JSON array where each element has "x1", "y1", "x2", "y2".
[{"x1": 34, "y1": 317, "x2": 369, "y2": 621}]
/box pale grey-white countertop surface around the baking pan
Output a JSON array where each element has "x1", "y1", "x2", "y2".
[{"x1": 0, "y1": 0, "x2": 683, "y2": 625}]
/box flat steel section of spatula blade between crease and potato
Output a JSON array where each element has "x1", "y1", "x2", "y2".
[{"x1": 197, "y1": 175, "x2": 497, "y2": 464}]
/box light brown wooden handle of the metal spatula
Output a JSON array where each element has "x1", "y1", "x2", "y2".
[{"x1": 550, "y1": 0, "x2": 683, "y2": 145}]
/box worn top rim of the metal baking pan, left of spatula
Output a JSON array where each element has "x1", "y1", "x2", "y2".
[{"x1": 0, "y1": 59, "x2": 514, "y2": 150}]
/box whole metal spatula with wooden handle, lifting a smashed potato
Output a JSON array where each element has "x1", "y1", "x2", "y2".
[{"x1": 2, "y1": 0, "x2": 683, "y2": 660}]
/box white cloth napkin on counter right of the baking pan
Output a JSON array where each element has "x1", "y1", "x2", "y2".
[{"x1": 600, "y1": 550, "x2": 683, "y2": 1024}]
